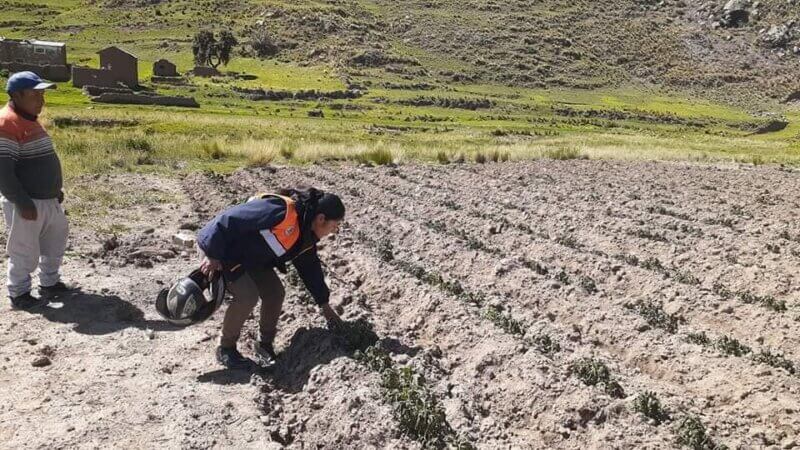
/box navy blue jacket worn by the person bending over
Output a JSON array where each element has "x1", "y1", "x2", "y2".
[{"x1": 197, "y1": 197, "x2": 330, "y2": 306}]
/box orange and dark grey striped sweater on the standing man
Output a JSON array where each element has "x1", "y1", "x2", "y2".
[{"x1": 0, "y1": 103, "x2": 62, "y2": 209}]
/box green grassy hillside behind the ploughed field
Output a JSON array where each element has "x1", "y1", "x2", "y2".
[{"x1": 0, "y1": 0, "x2": 800, "y2": 173}]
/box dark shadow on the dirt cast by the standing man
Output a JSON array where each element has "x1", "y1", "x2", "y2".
[{"x1": 28, "y1": 289, "x2": 181, "y2": 335}]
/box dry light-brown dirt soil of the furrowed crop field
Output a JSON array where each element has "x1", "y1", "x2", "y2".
[{"x1": 0, "y1": 161, "x2": 800, "y2": 449}]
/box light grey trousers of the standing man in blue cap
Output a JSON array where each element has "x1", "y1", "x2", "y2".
[{"x1": 2, "y1": 198, "x2": 69, "y2": 297}]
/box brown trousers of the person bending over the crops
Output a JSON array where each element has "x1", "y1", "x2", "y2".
[{"x1": 219, "y1": 268, "x2": 286, "y2": 348}]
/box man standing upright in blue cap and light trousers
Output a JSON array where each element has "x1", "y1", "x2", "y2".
[{"x1": 0, "y1": 72, "x2": 69, "y2": 310}]
